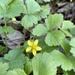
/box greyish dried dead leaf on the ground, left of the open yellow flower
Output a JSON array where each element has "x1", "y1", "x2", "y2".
[{"x1": 1, "y1": 30, "x2": 25, "y2": 49}]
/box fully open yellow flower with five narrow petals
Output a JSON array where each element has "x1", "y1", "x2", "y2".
[{"x1": 26, "y1": 40, "x2": 42, "y2": 56}]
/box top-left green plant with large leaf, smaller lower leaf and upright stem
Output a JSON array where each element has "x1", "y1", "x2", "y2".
[{"x1": 0, "y1": 0, "x2": 24, "y2": 50}]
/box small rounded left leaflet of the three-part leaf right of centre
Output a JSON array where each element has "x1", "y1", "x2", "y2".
[{"x1": 33, "y1": 24, "x2": 47, "y2": 36}]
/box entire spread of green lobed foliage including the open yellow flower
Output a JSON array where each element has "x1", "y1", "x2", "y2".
[{"x1": 0, "y1": 0, "x2": 75, "y2": 75}]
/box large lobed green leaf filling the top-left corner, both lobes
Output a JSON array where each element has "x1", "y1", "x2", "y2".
[{"x1": 0, "y1": 0, "x2": 25, "y2": 18}]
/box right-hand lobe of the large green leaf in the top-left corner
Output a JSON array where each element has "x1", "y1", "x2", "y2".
[{"x1": 6, "y1": 0, "x2": 25, "y2": 18}]
